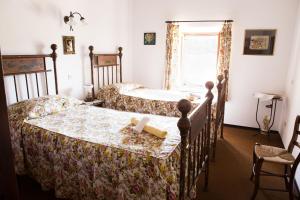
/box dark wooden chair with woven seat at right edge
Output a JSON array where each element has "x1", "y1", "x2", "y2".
[{"x1": 250, "y1": 115, "x2": 300, "y2": 200}]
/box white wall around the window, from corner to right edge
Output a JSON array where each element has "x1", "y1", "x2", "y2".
[{"x1": 132, "y1": 0, "x2": 298, "y2": 129}]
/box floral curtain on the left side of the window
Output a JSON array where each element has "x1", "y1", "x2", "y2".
[{"x1": 164, "y1": 23, "x2": 180, "y2": 90}]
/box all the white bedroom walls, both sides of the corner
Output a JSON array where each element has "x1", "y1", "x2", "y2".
[{"x1": 0, "y1": 0, "x2": 298, "y2": 129}]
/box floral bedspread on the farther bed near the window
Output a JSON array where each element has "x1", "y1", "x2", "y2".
[{"x1": 97, "y1": 83, "x2": 219, "y2": 142}]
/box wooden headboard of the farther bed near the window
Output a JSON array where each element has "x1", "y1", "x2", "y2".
[{"x1": 89, "y1": 46, "x2": 123, "y2": 99}]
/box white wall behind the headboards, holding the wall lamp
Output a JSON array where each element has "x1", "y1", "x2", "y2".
[{"x1": 0, "y1": 0, "x2": 132, "y2": 103}]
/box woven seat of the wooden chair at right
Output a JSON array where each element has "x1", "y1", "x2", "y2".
[{"x1": 254, "y1": 144, "x2": 295, "y2": 165}]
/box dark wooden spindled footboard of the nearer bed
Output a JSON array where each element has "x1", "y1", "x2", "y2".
[{"x1": 177, "y1": 82, "x2": 214, "y2": 200}]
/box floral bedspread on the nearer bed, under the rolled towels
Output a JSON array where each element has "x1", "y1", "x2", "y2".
[{"x1": 11, "y1": 97, "x2": 180, "y2": 199}]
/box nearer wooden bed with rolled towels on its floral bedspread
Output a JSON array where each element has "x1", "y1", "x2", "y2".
[{"x1": 1, "y1": 45, "x2": 218, "y2": 199}]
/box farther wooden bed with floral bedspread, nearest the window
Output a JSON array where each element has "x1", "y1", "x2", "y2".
[{"x1": 89, "y1": 46, "x2": 228, "y2": 160}]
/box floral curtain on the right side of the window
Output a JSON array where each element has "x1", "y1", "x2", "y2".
[{"x1": 217, "y1": 22, "x2": 232, "y2": 101}]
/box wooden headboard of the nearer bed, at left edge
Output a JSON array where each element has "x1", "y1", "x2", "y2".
[{"x1": 1, "y1": 44, "x2": 58, "y2": 102}]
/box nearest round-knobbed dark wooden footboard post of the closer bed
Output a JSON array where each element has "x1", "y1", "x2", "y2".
[{"x1": 177, "y1": 99, "x2": 192, "y2": 200}]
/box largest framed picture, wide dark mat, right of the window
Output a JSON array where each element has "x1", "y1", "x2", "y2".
[{"x1": 244, "y1": 29, "x2": 276, "y2": 56}]
